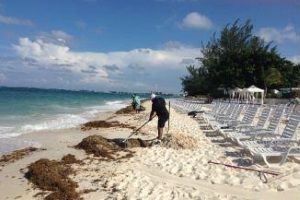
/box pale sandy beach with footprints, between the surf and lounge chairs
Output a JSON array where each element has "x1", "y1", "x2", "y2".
[{"x1": 0, "y1": 101, "x2": 300, "y2": 200}]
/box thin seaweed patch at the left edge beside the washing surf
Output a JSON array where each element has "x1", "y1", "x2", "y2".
[{"x1": 0, "y1": 147, "x2": 43, "y2": 166}]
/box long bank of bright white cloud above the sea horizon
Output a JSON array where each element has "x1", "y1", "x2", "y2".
[{"x1": 14, "y1": 38, "x2": 200, "y2": 87}]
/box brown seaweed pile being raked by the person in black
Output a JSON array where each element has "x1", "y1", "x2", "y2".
[{"x1": 75, "y1": 135, "x2": 149, "y2": 160}]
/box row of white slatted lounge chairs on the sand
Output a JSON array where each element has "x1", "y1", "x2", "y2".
[{"x1": 172, "y1": 100, "x2": 300, "y2": 166}]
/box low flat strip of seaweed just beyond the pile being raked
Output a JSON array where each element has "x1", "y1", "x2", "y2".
[{"x1": 81, "y1": 120, "x2": 135, "y2": 131}]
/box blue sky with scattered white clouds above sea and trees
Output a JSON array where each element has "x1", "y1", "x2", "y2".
[{"x1": 0, "y1": 0, "x2": 300, "y2": 93}]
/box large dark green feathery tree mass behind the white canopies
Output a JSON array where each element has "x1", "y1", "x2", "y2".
[{"x1": 181, "y1": 20, "x2": 300, "y2": 95}]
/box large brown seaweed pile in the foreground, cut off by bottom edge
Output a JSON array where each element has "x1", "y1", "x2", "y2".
[{"x1": 25, "y1": 154, "x2": 80, "y2": 200}]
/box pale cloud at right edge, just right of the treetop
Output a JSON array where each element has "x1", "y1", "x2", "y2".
[{"x1": 257, "y1": 25, "x2": 300, "y2": 43}]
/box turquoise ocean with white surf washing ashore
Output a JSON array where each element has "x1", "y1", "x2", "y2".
[{"x1": 0, "y1": 87, "x2": 131, "y2": 153}]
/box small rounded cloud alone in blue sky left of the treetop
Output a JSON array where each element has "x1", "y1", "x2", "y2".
[{"x1": 181, "y1": 12, "x2": 213, "y2": 29}]
